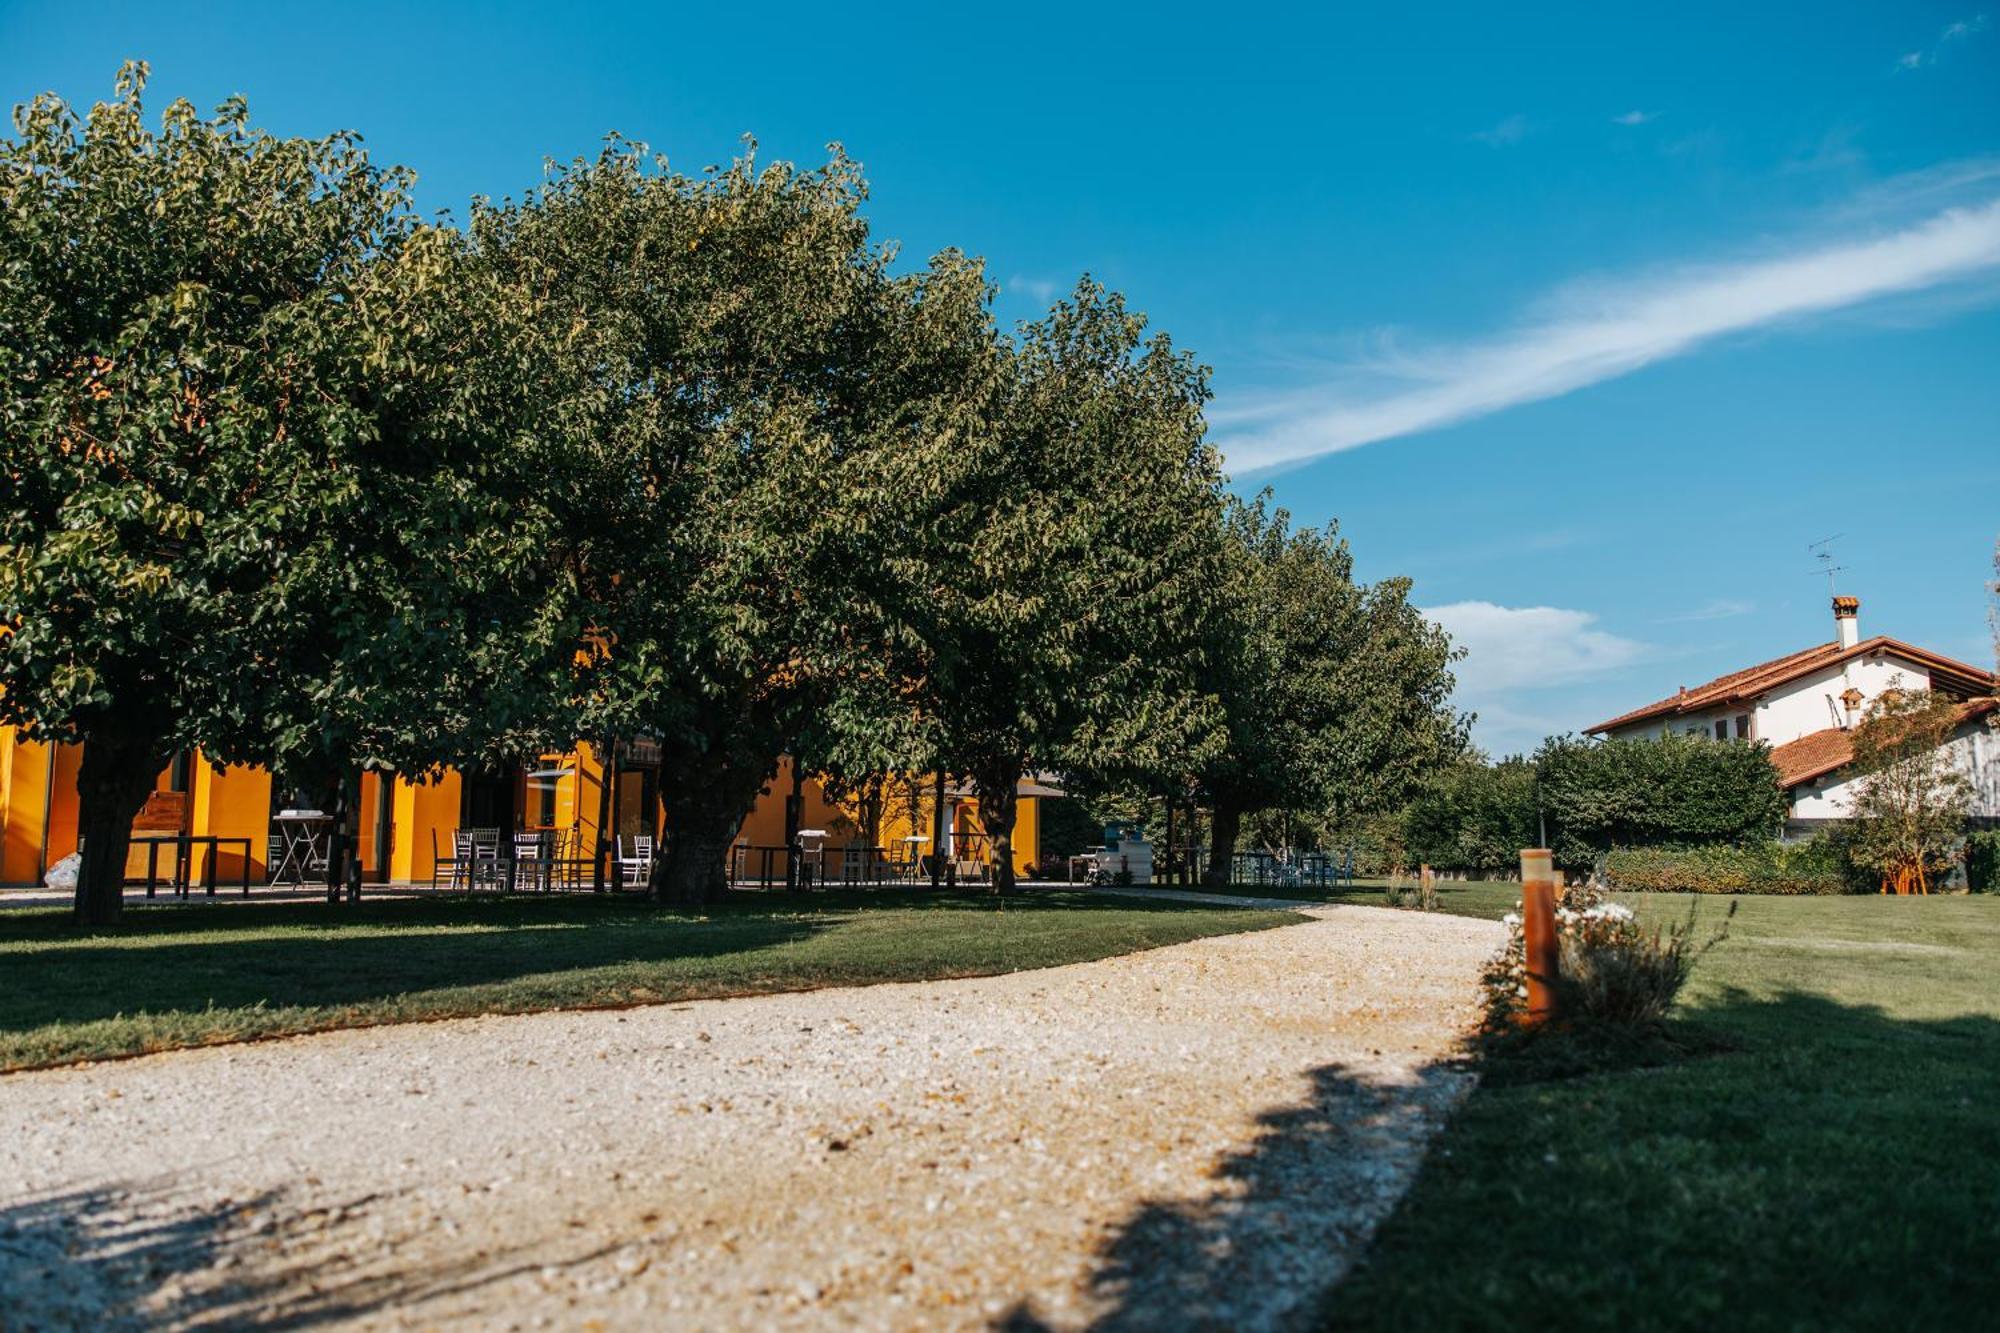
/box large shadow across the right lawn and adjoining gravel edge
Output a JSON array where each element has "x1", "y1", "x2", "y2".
[{"x1": 1002, "y1": 993, "x2": 2000, "y2": 1331}]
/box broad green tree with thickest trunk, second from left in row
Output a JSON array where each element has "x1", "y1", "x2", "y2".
[{"x1": 472, "y1": 140, "x2": 990, "y2": 901}]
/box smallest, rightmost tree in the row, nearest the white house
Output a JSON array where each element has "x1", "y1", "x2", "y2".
[{"x1": 1194, "y1": 496, "x2": 1466, "y2": 883}]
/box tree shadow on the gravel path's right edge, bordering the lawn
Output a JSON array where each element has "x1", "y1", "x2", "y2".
[{"x1": 996, "y1": 1065, "x2": 1470, "y2": 1333}]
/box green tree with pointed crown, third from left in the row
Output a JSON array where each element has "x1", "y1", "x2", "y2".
[{"x1": 898, "y1": 280, "x2": 1220, "y2": 891}]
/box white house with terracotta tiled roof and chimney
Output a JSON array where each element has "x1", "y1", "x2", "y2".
[{"x1": 1590, "y1": 596, "x2": 2000, "y2": 831}]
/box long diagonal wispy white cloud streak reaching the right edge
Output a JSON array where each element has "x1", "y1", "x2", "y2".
[{"x1": 1210, "y1": 169, "x2": 2000, "y2": 472}]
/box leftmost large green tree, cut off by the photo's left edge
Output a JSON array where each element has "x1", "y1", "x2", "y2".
[{"x1": 0, "y1": 66, "x2": 560, "y2": 921}]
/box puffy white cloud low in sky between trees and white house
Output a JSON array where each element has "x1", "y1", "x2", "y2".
[{"x1": 1424, "y1": 602, "x2": 1654, "y2": 755}]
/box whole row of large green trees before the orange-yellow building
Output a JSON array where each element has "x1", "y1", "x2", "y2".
[{"x1": 0, "y1": 66, "x2": 1464, "y2": 921}]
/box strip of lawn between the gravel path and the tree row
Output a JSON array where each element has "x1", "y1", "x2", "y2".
[{"x1": 0, "y1": 891, "x2": 1300, "y2": 1071}]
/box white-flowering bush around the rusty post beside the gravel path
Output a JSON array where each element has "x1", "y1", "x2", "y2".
[{"x1": 1482, "y1": 887, "x2": 1736, "y2": 1031}]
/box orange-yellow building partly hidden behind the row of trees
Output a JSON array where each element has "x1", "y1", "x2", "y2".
[{"x1": 0, "y1": 727, "x2": 1056, "y2": 887}]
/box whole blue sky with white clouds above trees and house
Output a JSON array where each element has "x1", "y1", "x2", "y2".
[{"x1": 11, "y1": 0, "x2": 2000, "y2": 751}]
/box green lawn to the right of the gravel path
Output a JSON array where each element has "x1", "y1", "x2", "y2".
[{"x1": 1330, "y1": 895, "x2": 2000, "y2": 1329}]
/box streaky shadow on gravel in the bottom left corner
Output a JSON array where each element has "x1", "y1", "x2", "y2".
[{"x1": 0, "y1": 1183, "x2": 610, "y2": 1329}]
